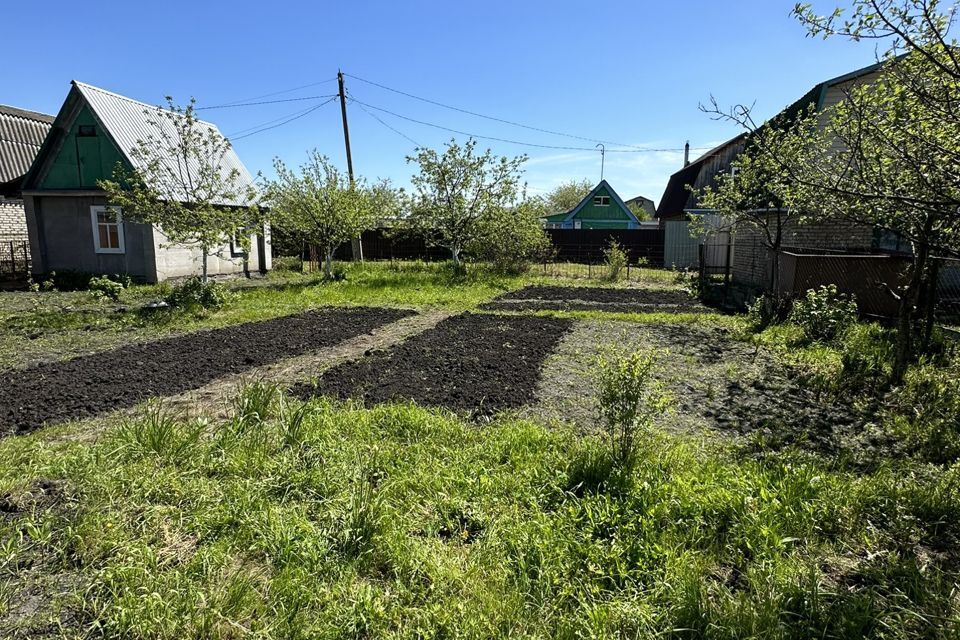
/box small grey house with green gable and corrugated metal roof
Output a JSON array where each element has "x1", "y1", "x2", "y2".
[{"x1": 22, "y1": 81, "x2": 271, "y2": 282}]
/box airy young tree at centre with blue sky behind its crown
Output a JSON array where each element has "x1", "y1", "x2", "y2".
[{"x1": 407, "y1": 138, "x2": 527, "y2": 270}]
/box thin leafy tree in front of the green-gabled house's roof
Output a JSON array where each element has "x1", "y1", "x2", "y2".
[{"x1": 98, "y1": 96, "x2": 264, "y2": 282}]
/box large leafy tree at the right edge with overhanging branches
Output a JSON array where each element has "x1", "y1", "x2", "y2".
[{"x1": 711, "y1": 0, "x2": 960, "y2": 382}]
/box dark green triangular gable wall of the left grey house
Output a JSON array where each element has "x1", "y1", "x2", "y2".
[{"x1": 39, "y1": 105, "x2": 129, "y2": 190}]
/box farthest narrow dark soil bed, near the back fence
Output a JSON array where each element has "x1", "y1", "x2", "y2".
[{"x1": 481, "y1": 285, "x2": 713, "y2": 313}]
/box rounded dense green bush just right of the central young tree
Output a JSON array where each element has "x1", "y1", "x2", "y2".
[{"x1": 467, "y1": 198, "x2": 551, "y2": 273}]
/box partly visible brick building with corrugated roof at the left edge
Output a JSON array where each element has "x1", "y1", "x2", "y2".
[{"x1": 0, "y1": 105, "x2": 53, "y2": 272}]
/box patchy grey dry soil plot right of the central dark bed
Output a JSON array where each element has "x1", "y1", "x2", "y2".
[{"x1": 527, "y1": 320, "x2": 869, "y2": 455}]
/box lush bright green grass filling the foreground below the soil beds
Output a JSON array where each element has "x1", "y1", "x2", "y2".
[{"x1": 0, "y1": 386, "x2": 960, "y2": 638}]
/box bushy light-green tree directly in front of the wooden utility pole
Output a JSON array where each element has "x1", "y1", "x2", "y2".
[{"x1": 267, "y1": 150, "x2": 387, "y2": 278}]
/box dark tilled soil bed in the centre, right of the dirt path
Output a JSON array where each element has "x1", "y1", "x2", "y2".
[{"x1": 294, "y1": 313, "x2": 573, "y2": 416}]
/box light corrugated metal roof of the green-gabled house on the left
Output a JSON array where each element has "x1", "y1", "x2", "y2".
[{"x1": 73, "y1": 80, "x2": 255, "y2": 206}]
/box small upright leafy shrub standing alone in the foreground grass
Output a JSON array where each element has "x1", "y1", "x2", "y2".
[{"x1": 596, "y1": 347, "x2": 670, "y2": 467}]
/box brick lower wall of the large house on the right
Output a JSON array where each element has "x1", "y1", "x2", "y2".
[{"x1": 731, "y1": 220, "x2": 873, "y2": 287}]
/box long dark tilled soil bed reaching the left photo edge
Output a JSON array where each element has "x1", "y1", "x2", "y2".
[{"x1": 0, "y1": 308, "x2": 413, "y2": 436}]
